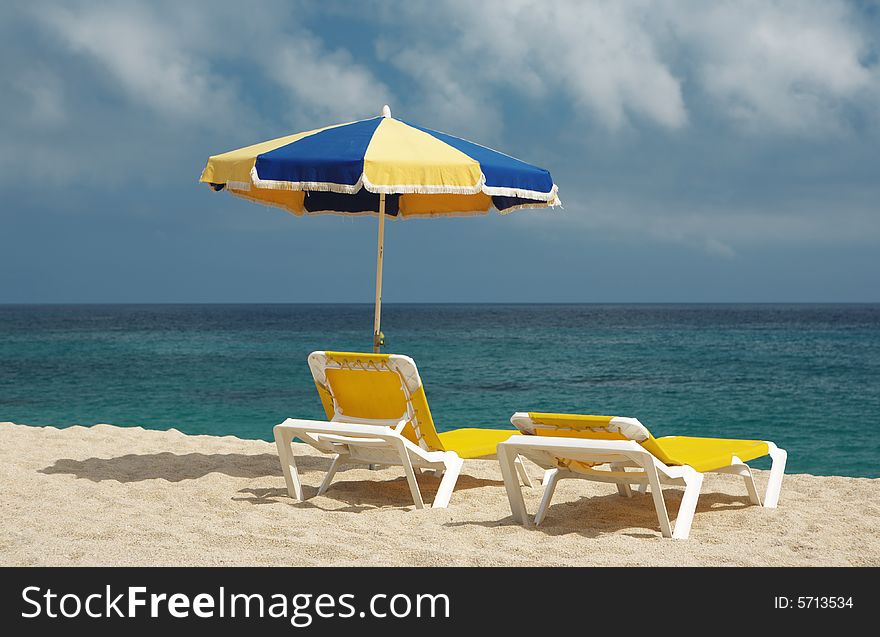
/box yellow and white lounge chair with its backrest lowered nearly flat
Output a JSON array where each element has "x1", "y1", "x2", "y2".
[{"x1": 498, "y1": 412, "x2": 787, "y2": 540}]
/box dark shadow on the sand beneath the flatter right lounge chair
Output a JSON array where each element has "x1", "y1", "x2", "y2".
[{"x1": 445, "y1": 490, "x2": 760, "y2": 539}]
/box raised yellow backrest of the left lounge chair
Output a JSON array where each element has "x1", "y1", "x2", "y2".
[{"x1": 309, "y1": 351, "x2": 444, "y2": 451}]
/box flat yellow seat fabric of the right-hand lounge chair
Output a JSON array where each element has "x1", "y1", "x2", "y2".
[{"x1": 641, "y1": 436, "x2": 770, "y2": 471}]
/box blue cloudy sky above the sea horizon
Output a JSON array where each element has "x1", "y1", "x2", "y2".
[{"x1": 0, "y1": 0, "x2": 880, "y2": 303}]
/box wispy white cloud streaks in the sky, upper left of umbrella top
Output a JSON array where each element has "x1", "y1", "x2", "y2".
[{"x1": 35, "y1": 3, "x2": 390, "y2": 133}]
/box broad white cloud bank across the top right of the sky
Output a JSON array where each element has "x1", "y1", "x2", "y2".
[{"x1": 378, "y1": 0, "x2": 880, "y2": 137}]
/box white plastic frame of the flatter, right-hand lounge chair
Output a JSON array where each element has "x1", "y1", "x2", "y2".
[{"x1": 498, "y1": 424, "x2": 787, "y2": 540}]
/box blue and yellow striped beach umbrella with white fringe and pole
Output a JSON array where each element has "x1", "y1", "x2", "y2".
[{"x1": 199, "y1": 105, "x2": 560, "y2": 352}]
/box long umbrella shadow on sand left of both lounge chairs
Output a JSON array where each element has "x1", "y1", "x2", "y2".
[{"x1": 39, "y1": 452, "x2": 322, "y2": 482}]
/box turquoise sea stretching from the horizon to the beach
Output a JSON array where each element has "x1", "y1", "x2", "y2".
[{"x1": 0, "y1": 305, "x2": 880, "y2": 477}]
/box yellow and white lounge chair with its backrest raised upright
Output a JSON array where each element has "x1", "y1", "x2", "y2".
[{"x1": 274, "y1": 352, "x2": 531, "y2": 509}]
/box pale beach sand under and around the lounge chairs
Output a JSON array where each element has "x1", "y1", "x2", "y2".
[{"x1": 0, "y1": 423, "x2": 880, "y2": 566}]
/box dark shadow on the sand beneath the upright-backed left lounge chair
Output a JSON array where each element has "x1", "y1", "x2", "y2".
[{"x1": 232, "y1": 472, "x2": 504, "y2": 513}]
